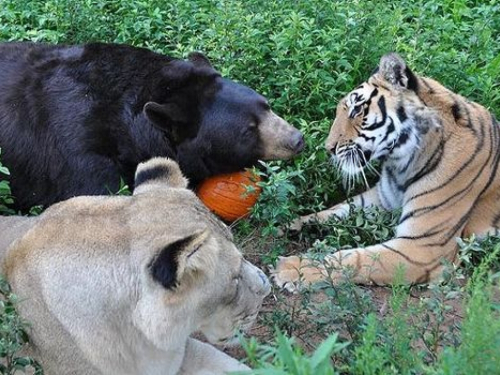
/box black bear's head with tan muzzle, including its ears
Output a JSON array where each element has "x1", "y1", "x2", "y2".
[{"x1": 144, "y1": 53, "x2": 304, "y2": 183}]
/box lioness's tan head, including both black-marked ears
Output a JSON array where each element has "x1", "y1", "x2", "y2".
[{"x1": 129, "y1": 158, "x2": 270, "y2": 345}]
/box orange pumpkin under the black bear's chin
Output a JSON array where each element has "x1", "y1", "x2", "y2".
[{"x1": 197, "y1": 171, "x2": 261, "y2": 222}]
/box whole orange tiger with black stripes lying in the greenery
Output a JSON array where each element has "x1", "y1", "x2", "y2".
[{"x1": 273, "y1": 53, "x2": 500, "y2": 290}]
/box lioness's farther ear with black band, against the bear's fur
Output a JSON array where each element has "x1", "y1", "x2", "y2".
[{"x1": 134, "y1": 158, "x2": 188, "y2": 195}]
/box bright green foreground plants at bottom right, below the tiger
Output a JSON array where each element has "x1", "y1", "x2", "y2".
[{"x1": 237, "y1": 253, "x2": 500, "y2": 375}]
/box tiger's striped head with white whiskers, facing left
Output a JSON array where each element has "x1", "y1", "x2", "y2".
[{"x1": 325, "y1": 53, "x2": 434, "y2": 185}]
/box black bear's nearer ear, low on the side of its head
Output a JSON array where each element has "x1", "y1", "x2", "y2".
[{"x1": 143, "y1": 102, "x2": 189, "y2": 144}]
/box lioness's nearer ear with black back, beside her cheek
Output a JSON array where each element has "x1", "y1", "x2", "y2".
[{"x1": 149, "y1": 229, "x2": 210, "y2": 289}]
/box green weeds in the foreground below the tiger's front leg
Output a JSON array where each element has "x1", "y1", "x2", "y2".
[{"x1": 244, "y1": 253, "x2": 500, "y2": 375}]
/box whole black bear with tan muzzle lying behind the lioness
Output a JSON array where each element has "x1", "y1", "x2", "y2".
[{"x1": 0, "y1": 43, "x2": 304, "y2": 210}]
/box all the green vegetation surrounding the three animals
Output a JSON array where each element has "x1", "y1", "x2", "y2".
[{"x1": 0, "y1": 0, "x2": 500, "y2": 375}]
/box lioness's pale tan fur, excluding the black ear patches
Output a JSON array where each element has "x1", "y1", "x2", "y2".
[{"x1": 0, "y1": 159, "x2": 270, "y2": 375}]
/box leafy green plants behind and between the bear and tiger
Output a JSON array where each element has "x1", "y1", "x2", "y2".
[{"x1": 0, "y1": 0, "x2": 500, "y2": 220}]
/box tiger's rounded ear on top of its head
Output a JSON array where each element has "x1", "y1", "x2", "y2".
[{"x1": 378, "y1": 53, "x2": 418, "y2": 91}]
